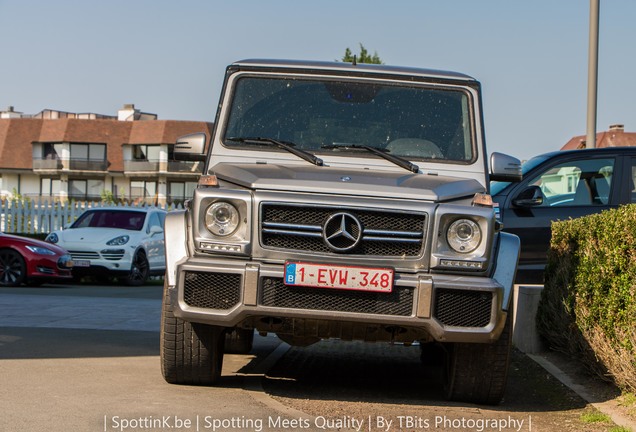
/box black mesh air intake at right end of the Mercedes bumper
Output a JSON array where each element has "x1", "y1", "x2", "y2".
[{"x1": 434, "y1": 288, "x2": 492, "y2": 327}]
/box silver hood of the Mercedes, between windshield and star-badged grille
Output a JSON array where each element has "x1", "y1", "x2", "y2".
[{"x1": 213, "y1": 163, "x2": 486, "y2": 202}]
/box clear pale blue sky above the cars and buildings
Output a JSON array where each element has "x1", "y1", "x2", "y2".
[{"x1": 0, "y1": 0, "x2": 636, "y2": 159}]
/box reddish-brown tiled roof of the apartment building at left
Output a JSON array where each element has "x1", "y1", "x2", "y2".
[{"x1": 0, "y1": 118, "x2": 212, "y2": 171}]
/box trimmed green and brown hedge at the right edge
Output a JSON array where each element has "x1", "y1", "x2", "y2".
[{"x1": 537, "y1": 205, "x2": 636, "y2": 391}]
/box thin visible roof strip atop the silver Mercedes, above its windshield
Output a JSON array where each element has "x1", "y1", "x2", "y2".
[{"x1": 232, "y1": 59, "x2": 476, "y2": 82}]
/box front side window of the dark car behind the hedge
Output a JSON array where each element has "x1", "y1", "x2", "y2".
[{"x1": 528, "y1": 159, "x2": 614, "y2": 207}]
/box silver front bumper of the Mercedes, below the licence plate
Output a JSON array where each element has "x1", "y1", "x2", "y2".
[{"x1": 169, "y1": 258, "x2": 511, "y2": 343}]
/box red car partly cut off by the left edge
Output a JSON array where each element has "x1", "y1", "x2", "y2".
[{"x1": 0, "y1": 233, "x2": 73, "y2": 287}]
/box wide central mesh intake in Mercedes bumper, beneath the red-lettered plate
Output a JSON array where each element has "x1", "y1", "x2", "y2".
[{"x1": 261, "y1": 277, "x2": 413, "y2": 316}]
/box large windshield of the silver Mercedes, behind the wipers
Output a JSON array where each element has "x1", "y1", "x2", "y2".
[{"x1": 224, "y1": 76, "x2": 474, "y2": 162}]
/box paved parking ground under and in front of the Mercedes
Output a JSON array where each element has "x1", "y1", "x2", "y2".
[{"x1": 0, "y1": 285, "x2": 632, "y2": 432}]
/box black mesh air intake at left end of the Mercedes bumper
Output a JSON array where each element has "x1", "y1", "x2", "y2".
[{"x1": 183, "y1": 272, "x2": 241, "y2": 310}]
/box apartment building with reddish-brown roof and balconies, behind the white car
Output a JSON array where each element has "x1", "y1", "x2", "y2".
[{"x1": 0, "y1": 104, "x2": 212, "y2": 203}]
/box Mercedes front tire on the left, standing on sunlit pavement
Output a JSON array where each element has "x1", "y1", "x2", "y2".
[{"x1": 160, "y1": 282, "x2": 225, "y2": 385}]
